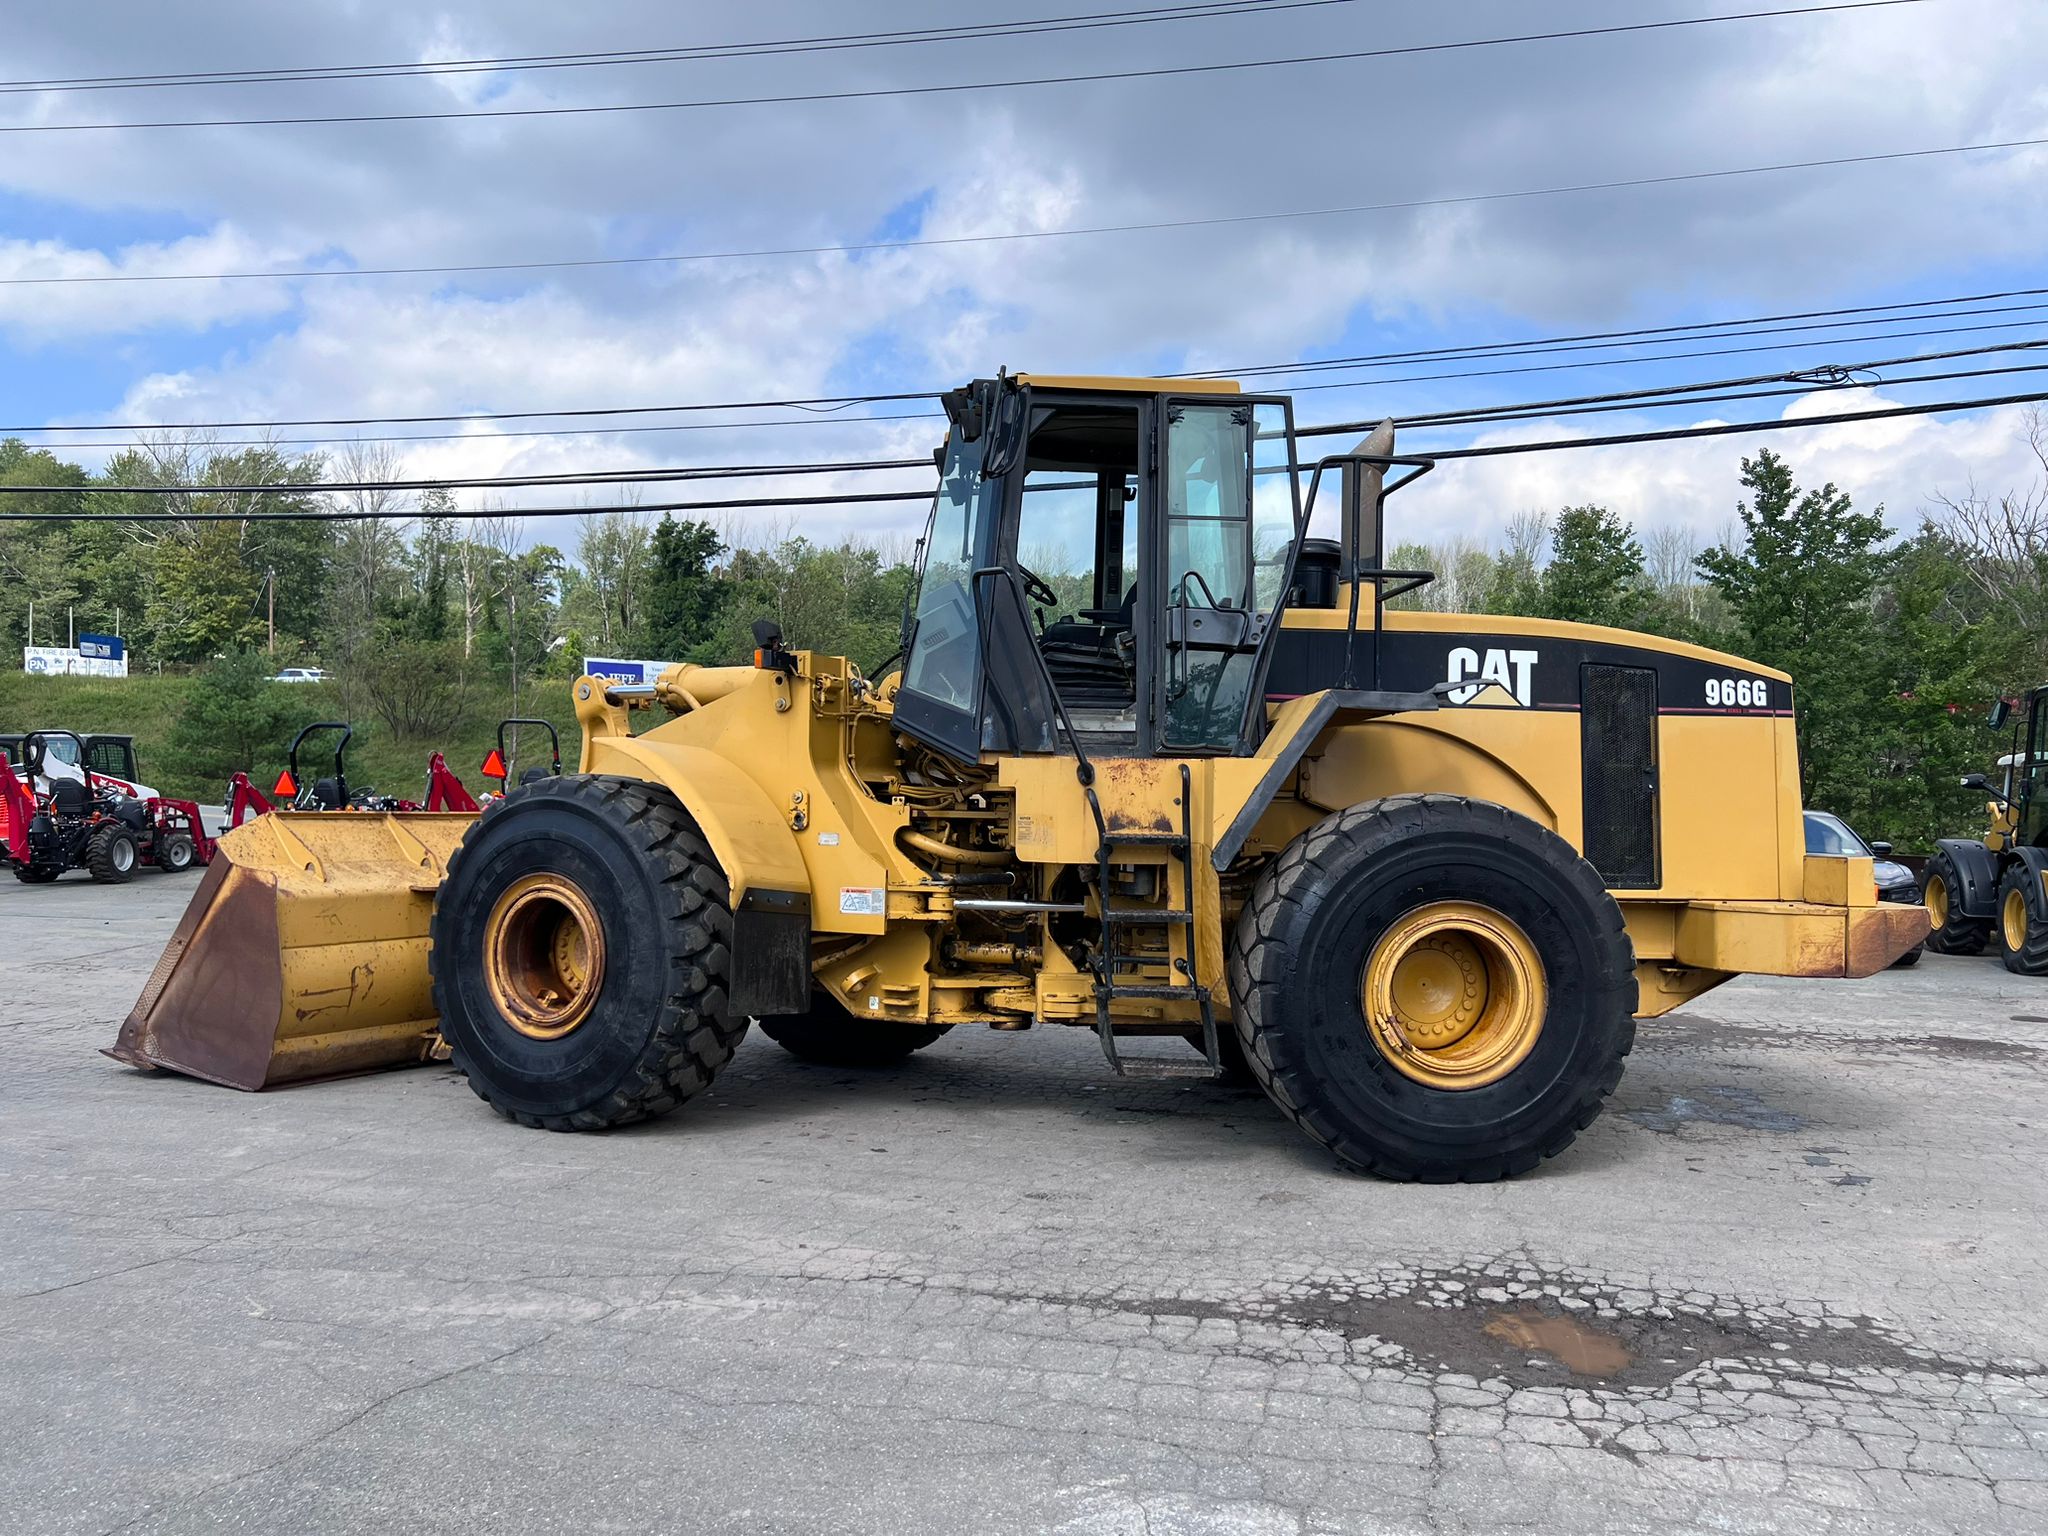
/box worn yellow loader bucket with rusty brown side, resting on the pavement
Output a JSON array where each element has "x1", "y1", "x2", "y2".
[{"x1": 106, "y1": 811, "x2": 475, "y2": 1092}]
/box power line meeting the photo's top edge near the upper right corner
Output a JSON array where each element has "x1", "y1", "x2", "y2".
[{"x1": 0, "y1": 0, "x2": 1929, "y2": 133}]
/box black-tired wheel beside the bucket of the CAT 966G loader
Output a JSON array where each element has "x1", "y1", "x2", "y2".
[{"x1": 428, "y1": 774, "x2": 748, "y2": 1130}]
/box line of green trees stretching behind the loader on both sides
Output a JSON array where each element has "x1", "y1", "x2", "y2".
[{"x1": 0, "y1": 418, "x2": 2048, "y2": 848}]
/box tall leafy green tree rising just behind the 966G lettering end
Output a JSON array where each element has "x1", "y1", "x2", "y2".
[{"x1": 1700, "y1": 449, "x2": 1892, "y2": 821}]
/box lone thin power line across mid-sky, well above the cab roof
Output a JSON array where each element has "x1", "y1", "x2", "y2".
[{"x1": 16, "y1": 128, "x2": 2023, "y2": 287}]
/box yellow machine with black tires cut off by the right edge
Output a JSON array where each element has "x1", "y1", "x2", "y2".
[{"x1": 1921, "y1": 684, "x2": 2048, "y2": 977}]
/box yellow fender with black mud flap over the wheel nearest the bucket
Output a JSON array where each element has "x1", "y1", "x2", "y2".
[{"x1": 586, "y1": 735, "x2": 811, "y2": 1014}]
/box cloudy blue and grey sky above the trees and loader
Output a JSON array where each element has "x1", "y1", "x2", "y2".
[{"x1": 0, "y1": 0, "x2": 2048, "y2": 541}]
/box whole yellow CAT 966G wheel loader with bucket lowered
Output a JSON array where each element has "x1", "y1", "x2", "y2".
[{"x1": 111, "y1": 377, "x2": 1927, "y2": 1180}]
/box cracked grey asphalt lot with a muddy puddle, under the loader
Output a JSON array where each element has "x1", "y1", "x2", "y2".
[{"x1": 0, "y1": 872, "x2": 2048, "y2": 1536}]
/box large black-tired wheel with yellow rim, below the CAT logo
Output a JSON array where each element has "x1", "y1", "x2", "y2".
[{"x1": 1231, "y1": 795, "x2": 1636, "y2": 1182}]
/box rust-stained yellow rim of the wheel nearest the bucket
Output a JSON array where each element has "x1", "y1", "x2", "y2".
[{"x1": 483, "y1": 874, "x2": 604, "y2": 1040}]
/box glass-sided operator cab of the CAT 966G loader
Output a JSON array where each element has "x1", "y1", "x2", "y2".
[{"x1": 895, "y1": 377, "x2": 1300, "y2": 762}]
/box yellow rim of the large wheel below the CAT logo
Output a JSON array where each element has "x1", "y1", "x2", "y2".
[{"x1": 1360, "y1": 901, "x2": 1548, "y2": 1090}]
